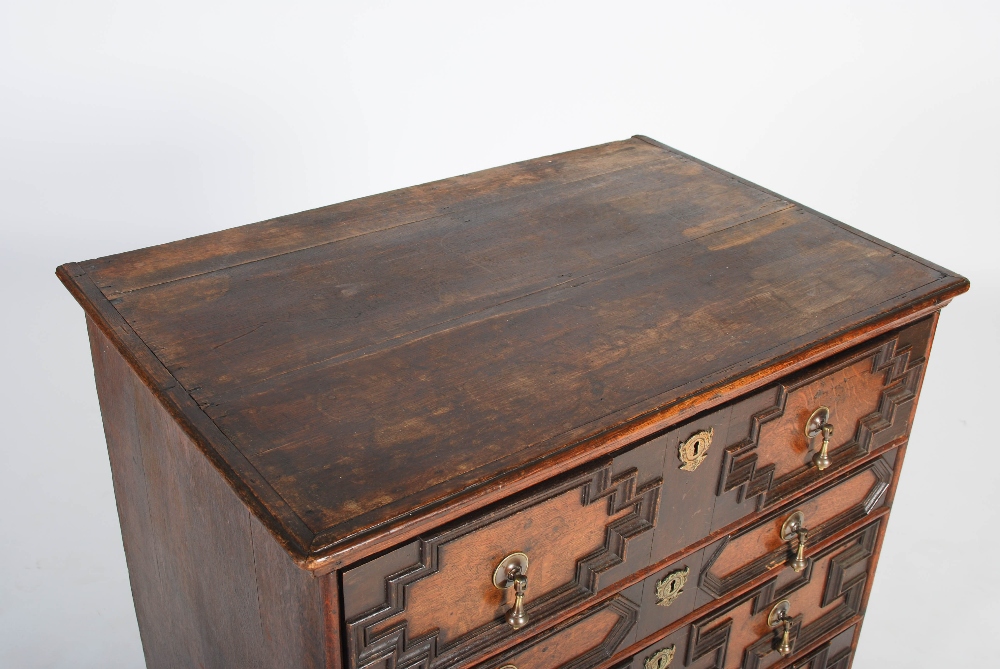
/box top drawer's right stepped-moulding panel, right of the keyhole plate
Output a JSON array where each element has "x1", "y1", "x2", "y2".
[{"x1": 712, "y1": 317, "x2": 934, "y2": 530}]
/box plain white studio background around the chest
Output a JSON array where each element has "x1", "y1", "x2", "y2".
[{"x1": 0, "y1": 0, "x2": 1000, "y2": 669}]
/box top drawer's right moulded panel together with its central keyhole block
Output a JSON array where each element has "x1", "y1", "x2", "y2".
[{"x1": 633, "y1": 317, "x2": 935, "y2": 563}]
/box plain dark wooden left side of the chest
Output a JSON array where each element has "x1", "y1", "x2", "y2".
[{"x1": 87, "y1": 319, "x2": 340, "y2": 669}]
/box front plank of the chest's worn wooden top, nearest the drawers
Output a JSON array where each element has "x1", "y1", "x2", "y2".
[{"x1": 227, "y1": 206, "x2": 933, "y2": 529}]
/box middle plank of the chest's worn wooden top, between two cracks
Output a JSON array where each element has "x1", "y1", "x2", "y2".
[{"x1": 118, "y1": 147, "x2": 790, "y2": 401}]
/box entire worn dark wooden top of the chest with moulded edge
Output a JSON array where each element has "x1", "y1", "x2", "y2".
[{"x1": 58, "y1": 137, "x2": 968, "y2": 568}]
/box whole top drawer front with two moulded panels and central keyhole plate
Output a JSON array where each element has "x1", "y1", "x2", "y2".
[{"x1": 342, "y1": 319, "x2": 934, "y2": 669}]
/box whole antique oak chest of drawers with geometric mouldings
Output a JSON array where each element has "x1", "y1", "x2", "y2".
[{"x1": 58, "y1": 137, "x2": 969, "y2": 669}]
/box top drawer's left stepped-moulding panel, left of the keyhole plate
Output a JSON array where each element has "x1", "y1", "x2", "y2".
[{"x1": 343, "y1": 460, "x2": 662, "y2": 669}]
